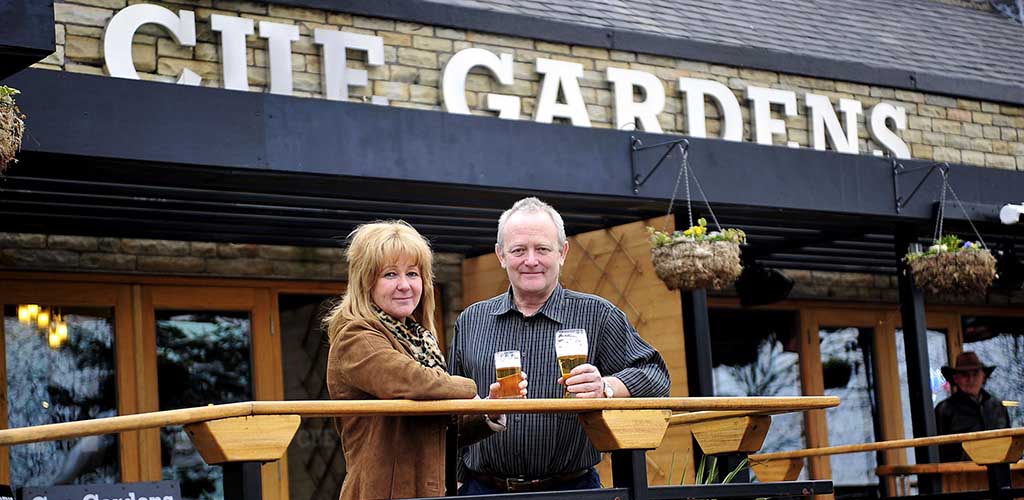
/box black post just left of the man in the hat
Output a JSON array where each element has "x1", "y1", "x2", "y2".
[{"x1": 896, "y1": 232, "x2": 942, "y2": 494}]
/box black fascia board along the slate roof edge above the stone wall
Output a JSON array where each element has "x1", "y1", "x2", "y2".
[{"x1": 272, "y1": 0, "x2": 1024, "y2": 106}]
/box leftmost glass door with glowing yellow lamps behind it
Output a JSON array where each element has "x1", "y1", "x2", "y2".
[{"x1": 0, "y1": 280, "x2": 139, "y2": 488}]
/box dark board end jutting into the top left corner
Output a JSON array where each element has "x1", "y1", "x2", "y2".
[{"x1": 0, "y1": 0, "x2": 56, "y2": 79}]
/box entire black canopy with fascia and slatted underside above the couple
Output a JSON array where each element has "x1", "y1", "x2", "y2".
[{"x1": 6, "y1": 70, "x2": 1024, "y2": 274}]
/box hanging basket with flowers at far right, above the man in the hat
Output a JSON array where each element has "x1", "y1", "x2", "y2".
[{"x1": 903, "y1": 235, "x2": 995, "y2": 295}]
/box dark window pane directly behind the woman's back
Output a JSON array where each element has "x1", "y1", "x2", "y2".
[{"x1": 278, "y1": 294, "x2": 345, "y2": 500}]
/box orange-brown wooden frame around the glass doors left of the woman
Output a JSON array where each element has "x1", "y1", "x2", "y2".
[{"x1": 0, "y1": 272, "x2": 345, "y2": 500}]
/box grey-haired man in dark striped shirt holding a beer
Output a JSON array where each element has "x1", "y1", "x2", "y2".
[{"x1": 449, "y1": 198, "x2": 670, "y2": 495}]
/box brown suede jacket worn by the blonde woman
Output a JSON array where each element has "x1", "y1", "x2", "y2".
[{"x1": 327, "y1": 321, "x2": 487, "y2": 500}]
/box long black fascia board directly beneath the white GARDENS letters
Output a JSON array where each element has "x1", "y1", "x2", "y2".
[{"x1": 11, "y1": 69, "x2": 1024, "y2": 222}]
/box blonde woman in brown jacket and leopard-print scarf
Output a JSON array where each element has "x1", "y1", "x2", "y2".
[{"x1": 326, "y1": 221, "x2": 526, "y2": 500}]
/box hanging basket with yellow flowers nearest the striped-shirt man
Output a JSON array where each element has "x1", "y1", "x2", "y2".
[{"x1": 647, "y1": 218, "x2": 746, "y2": 290}]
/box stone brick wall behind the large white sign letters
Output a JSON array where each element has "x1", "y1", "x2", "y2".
[{"x1": 37, "y1": 0, "x2": 1024, "y2": 170}]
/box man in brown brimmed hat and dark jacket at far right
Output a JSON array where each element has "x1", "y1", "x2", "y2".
[{"x1": 935, "y1": 351, "x2": 1010, "y2": 462}]
